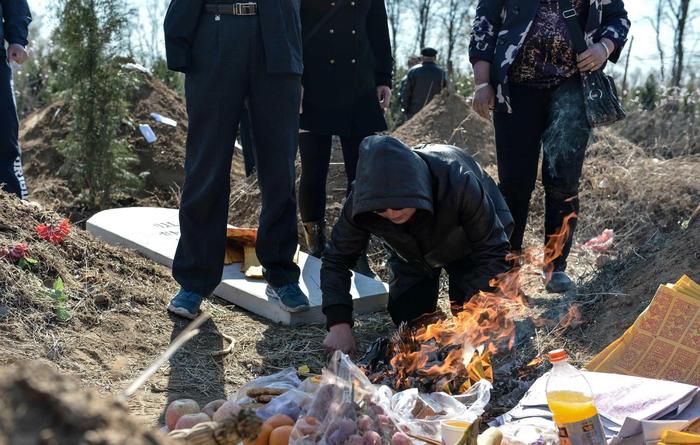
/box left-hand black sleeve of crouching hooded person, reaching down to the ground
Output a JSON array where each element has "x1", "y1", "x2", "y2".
[{"x1": 321, "y1": 199, "x2": 369, "y2": 328}]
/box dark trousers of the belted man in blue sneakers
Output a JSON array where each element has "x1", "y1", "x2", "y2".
[{"x1": 173, "y1": 14, "x2": 301, "y2": 295}]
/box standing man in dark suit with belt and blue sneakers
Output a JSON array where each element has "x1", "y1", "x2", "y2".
[{"x1": 164, "y1": 0, "x2": 309, "y2": 318}]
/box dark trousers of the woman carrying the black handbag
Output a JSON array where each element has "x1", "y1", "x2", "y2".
[{"x1": 493, "y1": 76, "x2": 591, "y2": 271}]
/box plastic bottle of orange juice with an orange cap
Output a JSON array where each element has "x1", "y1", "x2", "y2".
[{"x1": 547, "y1": 349, "x2": 607, "y2": 445}]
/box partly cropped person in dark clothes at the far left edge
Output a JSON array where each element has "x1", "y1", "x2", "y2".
[{"x1": 0, "y1": 0, "x2": 32, "y2": 199}]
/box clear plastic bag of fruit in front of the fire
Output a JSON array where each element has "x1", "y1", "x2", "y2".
[{"x1": 289, "y1": 352, "x2": 413, "y2": 445}]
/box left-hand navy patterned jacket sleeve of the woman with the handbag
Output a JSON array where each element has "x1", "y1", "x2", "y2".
[{"x1": 469, "y1": 0, "x2": 504, "y2": 64}]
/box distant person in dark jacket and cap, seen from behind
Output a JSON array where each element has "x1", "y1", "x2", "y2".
[{"x1": 401, "y1": 48, "x2": 447, "y2": 119}]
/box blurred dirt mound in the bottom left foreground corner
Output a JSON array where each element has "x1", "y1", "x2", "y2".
[{"x1": 0, "y1": 362, "x2": 175, "y2": 445}]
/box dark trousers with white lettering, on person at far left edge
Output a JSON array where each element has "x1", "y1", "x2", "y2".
[{"x1": 0, "y1": 57, "x2": 27, "y2": 198}]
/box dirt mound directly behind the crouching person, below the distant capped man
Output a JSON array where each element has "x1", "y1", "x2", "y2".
[{"x1": 392, "y1": 90, "x2": 496, "y2": 165}]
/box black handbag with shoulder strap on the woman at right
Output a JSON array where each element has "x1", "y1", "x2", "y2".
[{"x1": 559, "y1": 0, "x2": 625, "y2": 127}]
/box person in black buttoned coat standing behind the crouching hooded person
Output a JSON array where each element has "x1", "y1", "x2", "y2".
[{"x1": 299, "y1": 0, "x2": 393, "y2": 275}]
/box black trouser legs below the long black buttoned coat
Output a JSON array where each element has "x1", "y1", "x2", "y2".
[{"x1": 299, "y1": 133, "x2": 365, "y2": 222}]
